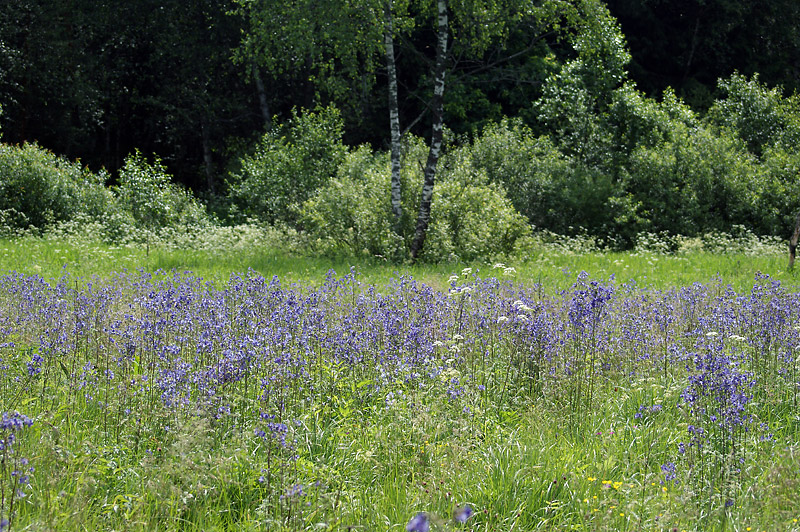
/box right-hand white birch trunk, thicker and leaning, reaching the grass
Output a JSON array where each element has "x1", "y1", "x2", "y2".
[{"x1": 411, "y1": 0, "x2": 447, "y2": 262}]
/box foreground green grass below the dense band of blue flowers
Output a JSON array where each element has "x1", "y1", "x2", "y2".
[{"x1": 7, "y1": 340, "x2": 800, "y2": 532}]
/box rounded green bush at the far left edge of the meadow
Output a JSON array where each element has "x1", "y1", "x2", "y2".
[{"x1": 0, "y1": 144, "x2": 114, "y2": 229}]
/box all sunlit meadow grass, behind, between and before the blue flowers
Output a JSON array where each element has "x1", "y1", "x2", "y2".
[{"x1": 0, "y1": 235, "x2": 800, "y2": 532}]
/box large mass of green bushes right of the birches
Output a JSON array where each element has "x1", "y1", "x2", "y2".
[{"x1": 532, "y1": 56, "x2": 800, "y2": 247}]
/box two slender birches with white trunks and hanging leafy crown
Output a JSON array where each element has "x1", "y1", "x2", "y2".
[{"x1": 235, "y1": 0, "x2": 576, "y2": 261}]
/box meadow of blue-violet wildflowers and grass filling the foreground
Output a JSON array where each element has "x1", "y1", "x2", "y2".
[{"x1": 0, "y1": 251, "x2": 800, "y2": 531}]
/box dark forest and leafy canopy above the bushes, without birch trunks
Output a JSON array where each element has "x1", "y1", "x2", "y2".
[{"x1": 0, "y1": 0, "x2": 800, "y2": 191}]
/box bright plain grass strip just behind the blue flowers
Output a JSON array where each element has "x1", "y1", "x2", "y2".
[{"x1": 0, "y1": 238, "x2": 798, "y2": 290}]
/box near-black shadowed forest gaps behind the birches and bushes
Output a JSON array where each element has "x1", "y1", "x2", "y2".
[{"x1": 0, "y1": 0, "x2": 800, "y2": 192}]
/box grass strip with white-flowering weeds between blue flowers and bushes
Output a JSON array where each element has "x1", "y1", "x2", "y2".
[{"x1": 0, "y1": 226, "x2": 797, "y2": 290}]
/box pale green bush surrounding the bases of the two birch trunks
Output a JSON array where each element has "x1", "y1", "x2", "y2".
[{"x1": 302, "y1": 138, "x2": 529, "y2": 262}]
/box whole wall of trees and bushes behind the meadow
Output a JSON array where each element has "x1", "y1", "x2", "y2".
[{"x1": 0, "y1": 0, "x2": 800, "y2": 260}]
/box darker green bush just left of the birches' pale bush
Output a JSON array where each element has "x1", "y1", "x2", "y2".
[{"x1": 229, "y1": 107, "x2": 346, "y2": 224}]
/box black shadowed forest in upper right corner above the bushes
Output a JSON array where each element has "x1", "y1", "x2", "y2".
[{"x1": 606, "y1": 0, "x2": 800, "y2": 110}]
